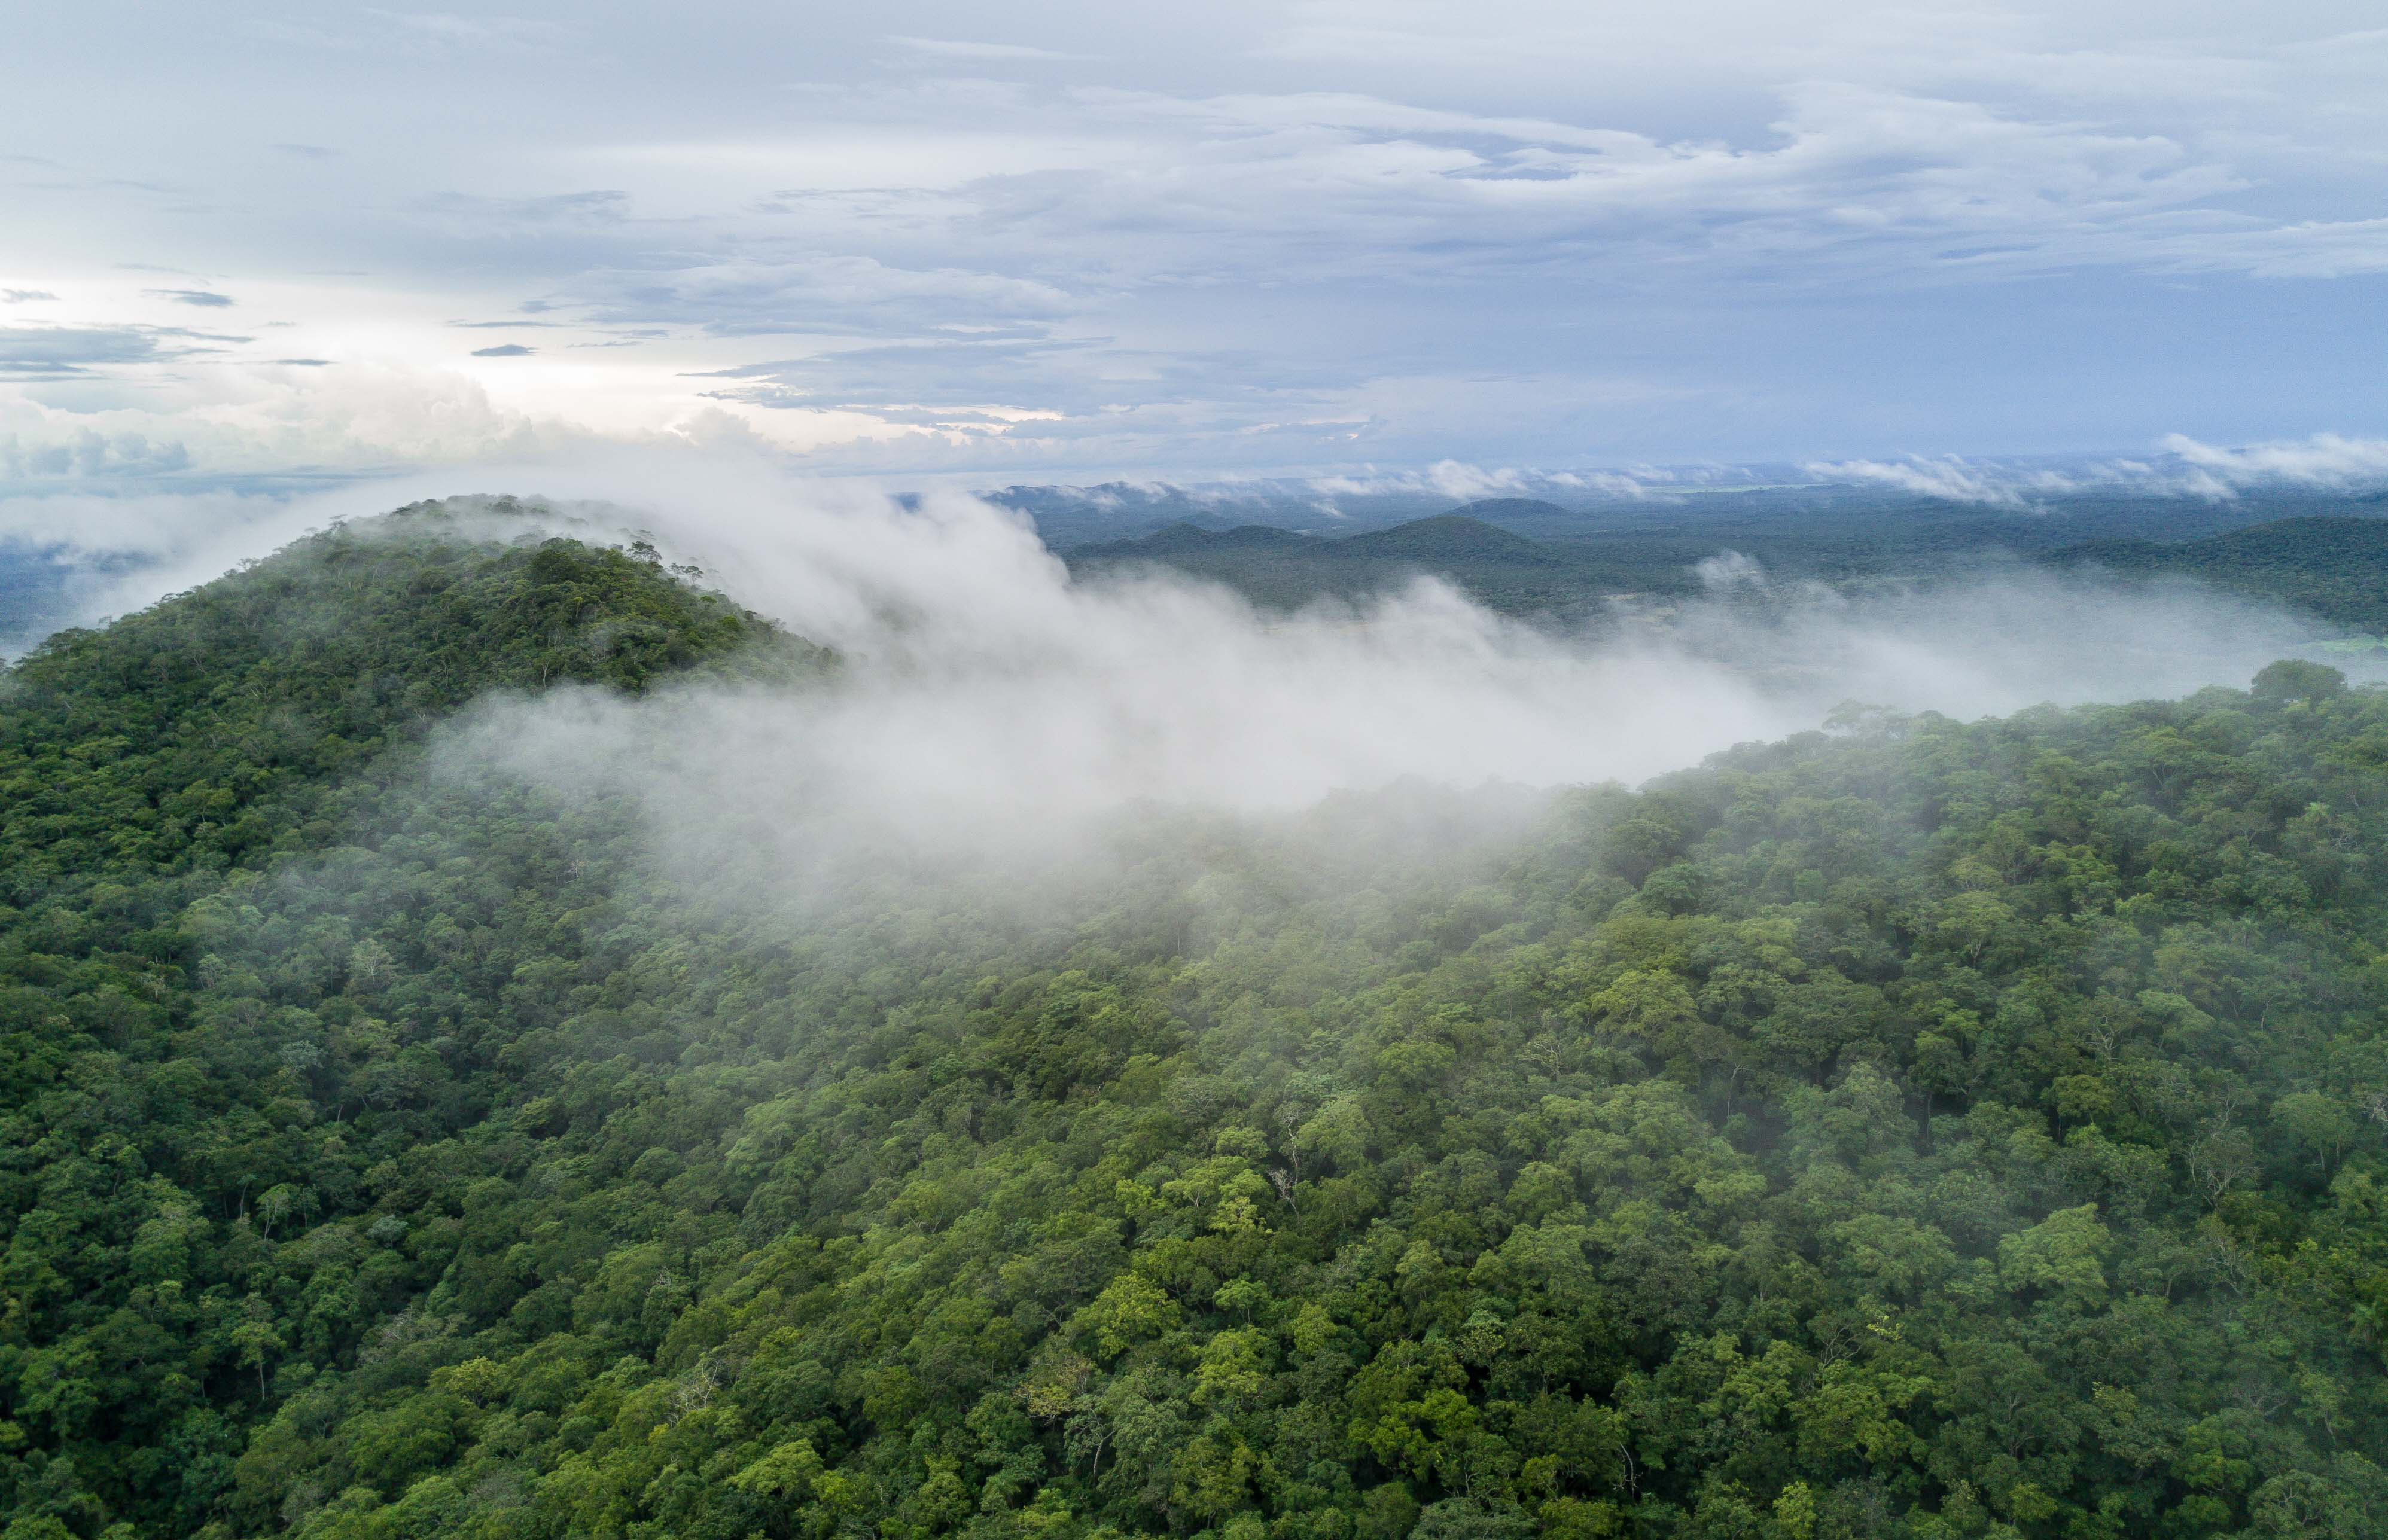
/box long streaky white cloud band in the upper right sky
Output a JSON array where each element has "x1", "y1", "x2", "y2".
[{"x1": 874, "y1": 81, "x2": 2311, "y2": 286}]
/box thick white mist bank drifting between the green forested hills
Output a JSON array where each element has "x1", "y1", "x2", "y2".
[{"x1": 382, "y1": 477, "x2": 2359, "y2": 893}]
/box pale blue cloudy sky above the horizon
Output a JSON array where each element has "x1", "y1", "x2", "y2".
[{"x1": 0, "y1": 0, "x2": 2388, "y2": 492}]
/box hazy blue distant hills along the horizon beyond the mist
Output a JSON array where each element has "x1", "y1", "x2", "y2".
[{"x1": 14, "y1": 482, "x2": 2388, "y2": 652}]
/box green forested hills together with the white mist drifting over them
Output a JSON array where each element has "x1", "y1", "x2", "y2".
[{"x1": 0, "y1": 487, "x2": 2388, "y2": 1540}]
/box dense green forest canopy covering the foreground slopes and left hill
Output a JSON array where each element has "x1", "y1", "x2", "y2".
[{"x1": 0, "y1": 520, "x2": 2388, "y2": 1540}]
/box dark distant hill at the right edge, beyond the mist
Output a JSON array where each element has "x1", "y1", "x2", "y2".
[{"x1": 2049, "y1": 516, "x2": 2388, "y2": 630}]
